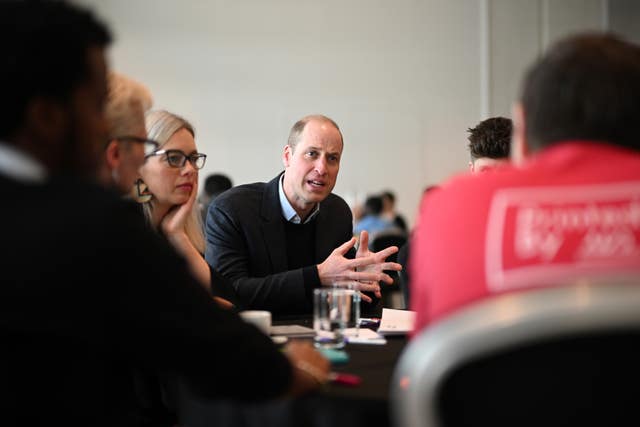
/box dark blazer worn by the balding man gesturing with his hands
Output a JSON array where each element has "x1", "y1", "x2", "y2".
[{"x1": 205, "y1": 175, "x2": 355, "y2": 316}]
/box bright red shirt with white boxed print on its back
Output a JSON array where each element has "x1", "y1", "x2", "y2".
[{"x1": 410, "y1": 141, "x2": 640, "y2": 330}]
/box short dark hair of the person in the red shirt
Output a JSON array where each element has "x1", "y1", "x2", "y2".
[{"x1": 520, "y1": 33, "x2": 640, "y2": 151}]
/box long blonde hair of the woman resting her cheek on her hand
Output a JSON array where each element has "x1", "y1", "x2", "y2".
[{"x1": 142, "y1": 110, "x2": 205, "y2": 254}]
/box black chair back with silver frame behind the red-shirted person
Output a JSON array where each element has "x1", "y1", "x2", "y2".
[{"x1": 390, "y1": 279, "x2": 640, "y2": 427}]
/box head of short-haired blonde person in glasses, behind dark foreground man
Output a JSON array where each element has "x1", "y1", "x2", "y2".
[{"x1": 99, "y1": 71, "x2": 158, "y2": 196}]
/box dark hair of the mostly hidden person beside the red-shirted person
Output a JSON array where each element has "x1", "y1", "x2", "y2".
[{"x1": 467, "y1": 117, "x2": 513, "y2": 161}]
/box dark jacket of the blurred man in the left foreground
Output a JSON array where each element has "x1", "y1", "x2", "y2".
[{"x1": 0, "y1": 174, "x2": 291, "y2": 426}]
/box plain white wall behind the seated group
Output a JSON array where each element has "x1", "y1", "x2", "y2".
[{"x1": 77, "y1": 0, "x2": 638, "y2": 229}]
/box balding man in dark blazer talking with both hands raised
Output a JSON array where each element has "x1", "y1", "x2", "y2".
[{"x1": 205, "y1": 115, "x2": 401, "y2": 317}]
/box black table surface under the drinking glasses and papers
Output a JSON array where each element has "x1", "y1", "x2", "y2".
[{"x1": 179, "y1": 319, "x2": 407, "y2": 427}]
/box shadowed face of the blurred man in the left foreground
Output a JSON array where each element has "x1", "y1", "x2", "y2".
[{"x1": 66, "y1": 47, "x2": 108, "y2": 177}]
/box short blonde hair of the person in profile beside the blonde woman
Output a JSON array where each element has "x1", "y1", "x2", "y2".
[{"x1": 105, "y1": 71, "x2": 153, "y2": 139}]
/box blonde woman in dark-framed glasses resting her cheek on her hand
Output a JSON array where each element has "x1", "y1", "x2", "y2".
[{"x1": 137, "y1": 110, "x2": 230, "y2": 305}]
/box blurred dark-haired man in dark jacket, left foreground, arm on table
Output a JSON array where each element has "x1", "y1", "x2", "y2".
[{"x1": 0, "y1": 2, "x2": 328, "y2": 426}]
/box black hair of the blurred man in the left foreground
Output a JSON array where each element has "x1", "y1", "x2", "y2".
[{"x1": 0, "y1": 1, "x2": 111, "y2": 138}]
